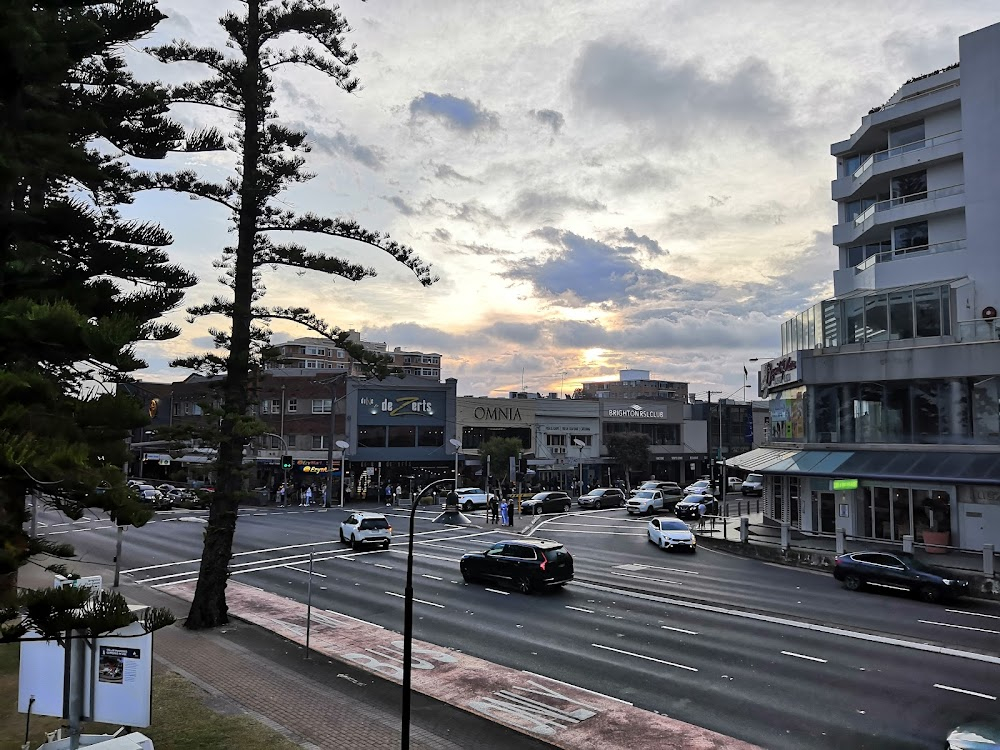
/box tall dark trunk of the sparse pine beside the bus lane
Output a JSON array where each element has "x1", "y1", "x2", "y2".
[{"x1": 185, "y1": 0, "x2": 261, "y2": 630}]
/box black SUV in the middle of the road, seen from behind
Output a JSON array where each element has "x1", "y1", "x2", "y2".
[{"x1": 459, "y1": 539, "x2": 573, "y2": 594}]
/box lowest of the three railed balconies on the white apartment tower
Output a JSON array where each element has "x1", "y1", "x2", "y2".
[{"x1": 833, "y1": 240, "x2": 967, "y2": 297}]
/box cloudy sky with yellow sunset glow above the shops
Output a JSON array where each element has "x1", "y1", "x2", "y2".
[{"x1": 126, "y1": 0, "x2": 1000, "y2": 398}]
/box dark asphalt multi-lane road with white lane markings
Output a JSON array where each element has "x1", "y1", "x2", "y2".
[{"x1": 33, "y1": 500, "x2": 1000, "y2": 748}]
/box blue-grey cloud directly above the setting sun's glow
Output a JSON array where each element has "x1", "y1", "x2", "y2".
[{"x1": 501, "y1": 227, "x2": 684, "y2": 308}]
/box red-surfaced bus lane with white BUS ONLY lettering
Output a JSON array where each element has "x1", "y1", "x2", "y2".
[{"x1": 161, "y1": 581, "x2": 755, "y2": 750}]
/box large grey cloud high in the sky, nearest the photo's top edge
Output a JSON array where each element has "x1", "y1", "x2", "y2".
[{"x1": 570, "y1": 39, "x2": 791, "y2": 145}]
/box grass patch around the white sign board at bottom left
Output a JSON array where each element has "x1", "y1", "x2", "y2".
[{"x1": 0, "y1": 643, "x2": 299, "y2": 750}]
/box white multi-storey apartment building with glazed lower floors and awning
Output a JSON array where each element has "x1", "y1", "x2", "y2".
[{"x1": 729, "y1": 24, "x2": 1000, "y2": 549}]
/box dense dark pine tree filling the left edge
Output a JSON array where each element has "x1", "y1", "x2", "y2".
[{"x1": 0, "y1": 0, "x2": 190, "y2": 640}]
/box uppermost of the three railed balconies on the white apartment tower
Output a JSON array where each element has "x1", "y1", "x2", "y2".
[{"x1": 830, "y1": 130, "x2": 963, "y2": 201}]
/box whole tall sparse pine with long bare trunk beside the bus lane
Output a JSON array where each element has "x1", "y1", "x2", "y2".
[{"x1": 146, "y1": 0, "x2": 436, "y2": 628}]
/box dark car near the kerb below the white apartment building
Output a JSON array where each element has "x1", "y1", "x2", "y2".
[{"x1": 833, "y1": 552, "x2": 969, "y2": 602}]
